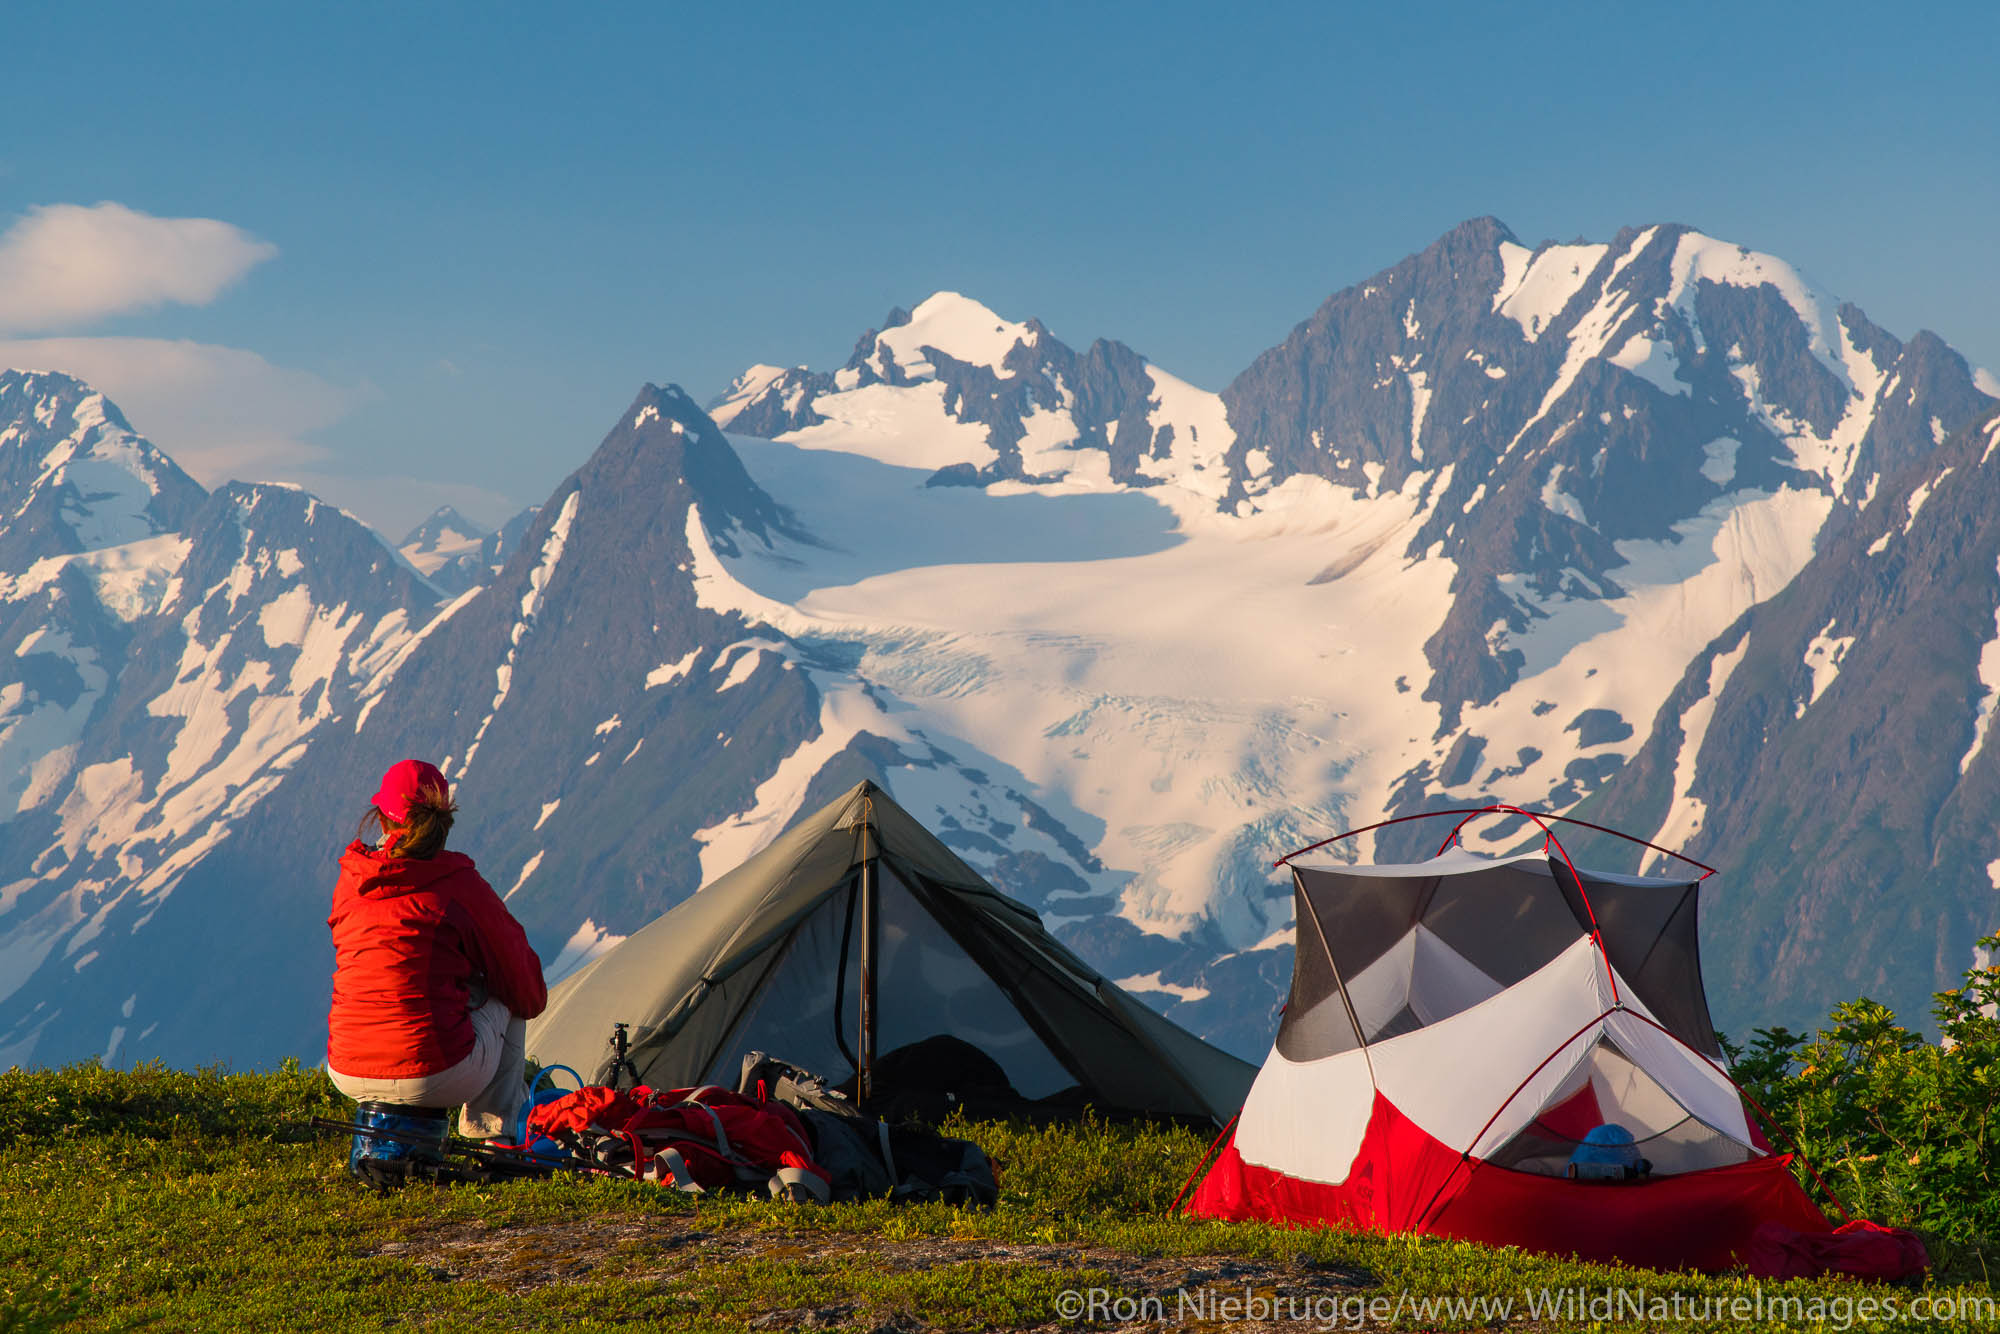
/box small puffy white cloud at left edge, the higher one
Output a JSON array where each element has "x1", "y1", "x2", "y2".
[{"x1": 0, "y1": 202, "x2": 278, "y2": 334}]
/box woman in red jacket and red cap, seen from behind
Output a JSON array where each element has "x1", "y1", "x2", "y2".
[{"x1": 326, "y1": 760, "x2": 548, "y2": 1140}]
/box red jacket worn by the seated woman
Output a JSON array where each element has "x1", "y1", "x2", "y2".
[{"x1": 326, "y1": 842, "x2": 548, "y2": 1080}]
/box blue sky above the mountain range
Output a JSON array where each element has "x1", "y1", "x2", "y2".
[{"x1": 0, "y1": 2, "x2": 2000, "y2": 538}]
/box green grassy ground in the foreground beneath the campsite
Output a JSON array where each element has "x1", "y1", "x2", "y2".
[{"x1": 0, "y1": 1066, "x2": 2000, "y2": 1334}]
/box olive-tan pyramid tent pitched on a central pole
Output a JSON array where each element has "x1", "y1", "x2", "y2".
[{"x1": 528, "y1": 782, "x2": 1256, "y2": 1126}]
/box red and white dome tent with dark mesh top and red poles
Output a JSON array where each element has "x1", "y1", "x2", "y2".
[{"x1": 1190, "y1": 806, "x2": 1840, "y2": 1270}]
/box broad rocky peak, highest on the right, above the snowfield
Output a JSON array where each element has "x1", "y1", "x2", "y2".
[{"x1": 1222, "y1": 220, "x2": 1992, "y2": 734}]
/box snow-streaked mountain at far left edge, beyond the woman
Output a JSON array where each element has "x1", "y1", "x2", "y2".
[{"x1": 0, "y1": 372, "x2": 436, "y2": 1064}]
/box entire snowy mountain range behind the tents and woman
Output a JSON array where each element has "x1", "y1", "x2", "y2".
[{"x1": 0, "y1": 220, "x2": 2000, "y2": 1062}]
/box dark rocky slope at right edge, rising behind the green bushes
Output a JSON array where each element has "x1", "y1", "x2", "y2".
[{"x1": 1596, "y1": 414, "x2": 2000, "y2": 1022}]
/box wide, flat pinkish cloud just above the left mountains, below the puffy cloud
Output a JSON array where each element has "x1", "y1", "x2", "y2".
[{"x1": 0, "y1": 338, "x2": 356, "y2": 486}]
